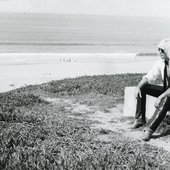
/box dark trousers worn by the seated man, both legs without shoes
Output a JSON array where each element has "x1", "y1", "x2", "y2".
[{"x1": 135, "y1": 84, "x2": 170, "y2": 131}]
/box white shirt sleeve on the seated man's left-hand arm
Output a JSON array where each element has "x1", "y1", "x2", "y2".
[{"x1": 144, "y1": 61, "x2": 161, "y2": 83}]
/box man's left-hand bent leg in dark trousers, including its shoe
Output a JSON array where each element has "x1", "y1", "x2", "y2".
[{"x1": 133, "y1": 84, "x2": 163, "y2": 128}]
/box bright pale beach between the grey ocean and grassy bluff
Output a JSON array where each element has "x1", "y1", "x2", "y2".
[{"x1": 0, "y1": 53, "x2": 158, "y2": 92}]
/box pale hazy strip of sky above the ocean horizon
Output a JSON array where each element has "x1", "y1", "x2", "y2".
[{"x1": 0, "y1": 0, "x2": 170, "y2": 17}]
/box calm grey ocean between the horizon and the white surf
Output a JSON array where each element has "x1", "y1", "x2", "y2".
[{"x1": 0, "y1": 14, "x2": 170, "y2": 54}]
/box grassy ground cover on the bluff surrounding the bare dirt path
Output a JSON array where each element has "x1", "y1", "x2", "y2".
[{"x1": 0, "y1": 74, "x2": 170, "y2": 170}]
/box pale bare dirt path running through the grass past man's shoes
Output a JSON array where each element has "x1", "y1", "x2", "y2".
[{"x1": 46, "y1": 98, "x2": 170, "y2": 152}]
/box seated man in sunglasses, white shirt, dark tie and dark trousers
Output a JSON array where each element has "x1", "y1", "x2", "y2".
[{"x1": 133, "y1": 39, "x2": 170, "y2": 141}]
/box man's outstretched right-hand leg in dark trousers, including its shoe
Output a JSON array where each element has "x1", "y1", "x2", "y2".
[{"x1": 142, "y1": 97, "x2": 170, "y2": 141}]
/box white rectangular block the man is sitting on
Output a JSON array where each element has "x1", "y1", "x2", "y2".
[{"x1": 123, "y1": 86, "x2": 156, "y2": 119}]
